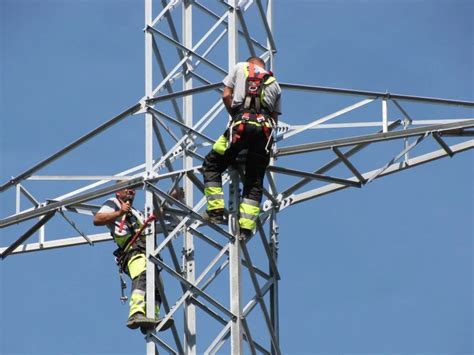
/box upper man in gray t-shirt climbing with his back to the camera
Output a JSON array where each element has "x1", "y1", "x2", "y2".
[{"x1": 203, "y1": 57, "x2": 281, "y2": 237}]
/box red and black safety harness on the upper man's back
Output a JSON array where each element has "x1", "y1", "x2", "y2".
[{"x1": 230, "y1": 63, "x2": 275, "y2": 148}]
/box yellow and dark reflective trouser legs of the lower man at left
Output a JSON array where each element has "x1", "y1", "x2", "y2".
[{"x1": 127, "y1": 253, "x2": 161, "y2": 318}]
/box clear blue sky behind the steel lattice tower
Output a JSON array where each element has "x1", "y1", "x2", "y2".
[{"x1": 0, "y1": 0, "x2": 474, "y2": 354}]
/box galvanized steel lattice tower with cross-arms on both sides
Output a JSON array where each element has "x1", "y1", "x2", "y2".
[{"x1": 0, "y1": 0, "x2": 474, "y2": 354}]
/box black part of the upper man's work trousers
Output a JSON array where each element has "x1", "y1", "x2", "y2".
[{"x1": 202, "y1": 122, "x2": 271, "y2": 203}]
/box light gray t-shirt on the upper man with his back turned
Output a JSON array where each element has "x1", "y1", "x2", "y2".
[{"x1": 222, "y1": 62, "x2": 281, "y2": 114}]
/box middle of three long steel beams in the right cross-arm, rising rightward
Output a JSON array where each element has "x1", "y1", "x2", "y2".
[{"x1": 276, "y1": 120, "x2": 474, "y2": 156}]
